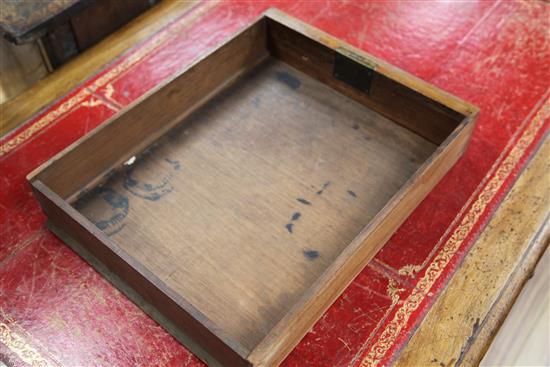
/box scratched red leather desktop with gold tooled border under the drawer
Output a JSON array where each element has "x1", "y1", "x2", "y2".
[{"x1": 0, "y1": 1, "x2": 550, "y2": 366}]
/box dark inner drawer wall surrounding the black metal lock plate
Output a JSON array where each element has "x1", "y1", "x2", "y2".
[{"x1": 267, "y1": 18, "x2": 470, "y2": 144}]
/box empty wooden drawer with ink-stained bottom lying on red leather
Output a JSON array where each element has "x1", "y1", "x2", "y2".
[{"x1": 29, "y1": 10, "x2": 478, "y2": 366}]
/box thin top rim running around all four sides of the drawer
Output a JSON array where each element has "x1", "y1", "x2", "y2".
[{"x1": 27, "y1": 8, "x2": 479, "y2": 365}]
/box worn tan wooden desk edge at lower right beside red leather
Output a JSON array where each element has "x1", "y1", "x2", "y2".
[{"x1": 396, "y1": 138, "x2": 550, "y2": 367}]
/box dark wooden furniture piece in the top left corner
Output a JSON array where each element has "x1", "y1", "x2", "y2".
[{"x1": 0, "y1": 0, "x2": 159, "y2": 70}]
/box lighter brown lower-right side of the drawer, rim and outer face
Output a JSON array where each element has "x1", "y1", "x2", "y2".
[{"x1": 248, "y1": 118, "x2": 474, "y2": 366}]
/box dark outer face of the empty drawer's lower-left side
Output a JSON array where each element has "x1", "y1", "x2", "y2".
[{"x1": 32, "y1": 180, "x2": 250, "y2": 366}]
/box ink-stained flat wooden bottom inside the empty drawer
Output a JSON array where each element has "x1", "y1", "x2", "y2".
[{"x1": 74, "y1": 59, "x2": 436, "y2": 350}]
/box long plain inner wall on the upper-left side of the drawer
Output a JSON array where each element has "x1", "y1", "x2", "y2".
[{"x1": 31, "y1": 20, "x2": 267, "y2": 201}]
